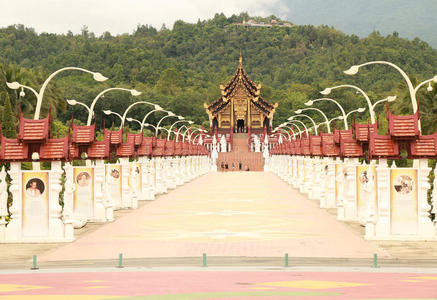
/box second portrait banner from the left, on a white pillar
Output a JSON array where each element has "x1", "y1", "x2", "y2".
[{"x1": 73, "y1": 167, "x2": 94, "y2": 218}]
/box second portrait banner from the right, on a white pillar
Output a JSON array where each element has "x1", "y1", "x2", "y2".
[{"x1": 356, "y1": 165, "x2": 378, "y2": 220}]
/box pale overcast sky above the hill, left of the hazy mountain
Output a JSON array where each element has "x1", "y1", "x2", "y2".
[{"x1": 0, "y1": 0, "x2": 289, "y2": 35}]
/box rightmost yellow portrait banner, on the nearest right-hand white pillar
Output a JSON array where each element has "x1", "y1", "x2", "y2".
[{"x1": 390, "y1": 169, "x2": 418, "y2": 235}]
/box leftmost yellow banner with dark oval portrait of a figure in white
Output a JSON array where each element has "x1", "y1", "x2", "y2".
[{"x1": 21, "y1": 171, "x2": 49, "y2": 237}]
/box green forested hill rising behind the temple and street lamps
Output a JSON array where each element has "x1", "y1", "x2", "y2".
[{"x1": 0, "y1": 14, "x2": 437, "y2": 134}]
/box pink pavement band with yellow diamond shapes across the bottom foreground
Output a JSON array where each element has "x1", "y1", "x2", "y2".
[{"x1": 0, "y1": 271, "x2": 437, "y2": 299}]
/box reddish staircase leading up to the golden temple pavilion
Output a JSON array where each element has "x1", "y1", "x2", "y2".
[{"x1": 217, "y1": 133, "x2": 264, "y2": 172}]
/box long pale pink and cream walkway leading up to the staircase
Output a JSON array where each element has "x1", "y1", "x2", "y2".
[{"x1": 40, "y1": 172, "x2": 389, "y2": 261}]
